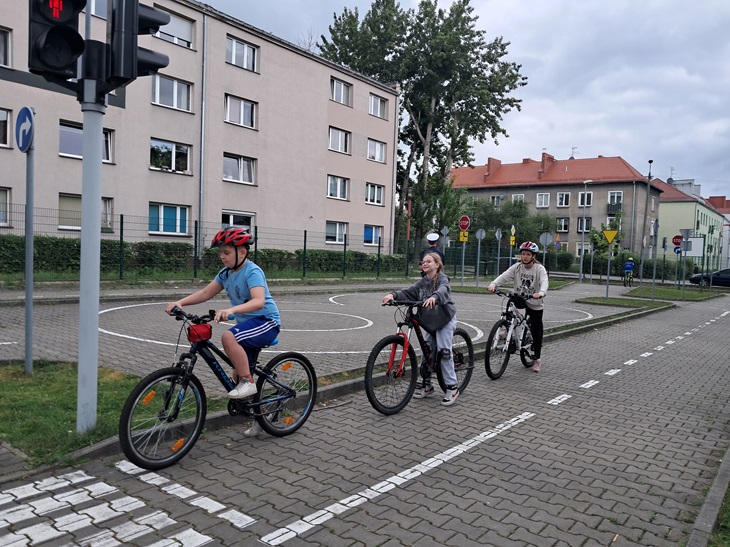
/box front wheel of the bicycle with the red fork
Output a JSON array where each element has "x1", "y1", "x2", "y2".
[{"x1": 365, "y1": 334, "x2": 418, "y2": 415}]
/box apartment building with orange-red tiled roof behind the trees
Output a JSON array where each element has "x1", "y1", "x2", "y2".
[{"x1": 452, "y1": 152, "x2": 661, "y2": 256}]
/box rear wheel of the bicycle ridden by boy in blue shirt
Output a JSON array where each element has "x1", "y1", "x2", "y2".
[{"x1": 255, "y1": 351, "x2": 317, "y2": 437}]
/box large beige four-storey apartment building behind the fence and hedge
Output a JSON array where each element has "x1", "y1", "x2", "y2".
[{"x1": 0, "y1": 0, "x2": 398, "y2": 251}]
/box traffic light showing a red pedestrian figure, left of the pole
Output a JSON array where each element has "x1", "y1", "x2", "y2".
[{"x1": 28, "y1": 0, "x2": 86, "y2": 80}]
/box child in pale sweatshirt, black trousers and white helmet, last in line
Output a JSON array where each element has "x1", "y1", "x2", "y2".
[{"x1": 487, "y1": 241, "x2": 548, "y2": 372}]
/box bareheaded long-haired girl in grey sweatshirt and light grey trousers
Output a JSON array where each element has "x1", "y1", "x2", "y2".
[{"x1": 383, "y1": 252, "x2": 459, "y2": 406}]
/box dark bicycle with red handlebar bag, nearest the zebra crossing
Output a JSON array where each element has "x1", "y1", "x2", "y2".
[{"x1": 119, "y1": 308, "x2": 317, "y2": 470}]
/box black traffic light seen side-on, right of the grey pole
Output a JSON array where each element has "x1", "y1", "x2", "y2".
[{"x1": 106, "y1": 0, "x2": 170, "y2": 87}]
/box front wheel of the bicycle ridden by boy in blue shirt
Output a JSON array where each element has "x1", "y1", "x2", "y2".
[{"x1": 119, "y1": 367, "x2": 207, "y2": 470}]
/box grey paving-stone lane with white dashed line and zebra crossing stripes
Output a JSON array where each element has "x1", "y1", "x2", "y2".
[{"x1": 0, "y1": 282, "x2": 730, "y2": 547}]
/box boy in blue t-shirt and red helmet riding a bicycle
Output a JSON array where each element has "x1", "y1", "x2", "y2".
[{"x1": 165, "y1": 226, "x2": 281, "y2": 399}]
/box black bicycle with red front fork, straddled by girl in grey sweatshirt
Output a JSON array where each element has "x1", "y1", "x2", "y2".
[{"x1": 365, "y1": 300, "x2": 474, "y2": 415}]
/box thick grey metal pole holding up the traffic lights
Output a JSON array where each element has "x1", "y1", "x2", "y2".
[{"x1": 76, "y1": 80, "x2": 106, "y2": 433}]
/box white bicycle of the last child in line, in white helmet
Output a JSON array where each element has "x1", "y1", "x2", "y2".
[{"x1": 484, "y1": 289, "x2": 535, "y2": 380}]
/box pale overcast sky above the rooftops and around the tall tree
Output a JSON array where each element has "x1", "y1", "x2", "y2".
[{"x1": 206, "y1": 0, "x2": 730, "y2": 198}]
